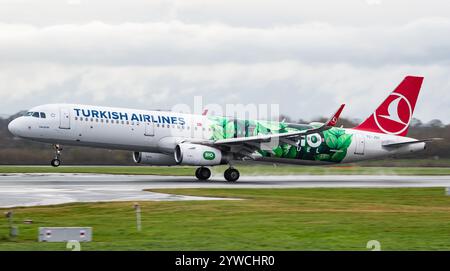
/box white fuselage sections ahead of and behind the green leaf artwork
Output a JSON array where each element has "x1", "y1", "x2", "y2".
[{"x1": 8, "y1": 104, "x2": 425, "y2": 163}]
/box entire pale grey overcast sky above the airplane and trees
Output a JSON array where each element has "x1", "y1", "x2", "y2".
[{"x1": 0, "y1": 0, "x2": 450, "y2": 123}]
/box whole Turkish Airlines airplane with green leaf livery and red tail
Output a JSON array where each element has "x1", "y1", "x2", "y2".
[{"x1": 8, "y1": 76, "x2": 434, "y2": 182}]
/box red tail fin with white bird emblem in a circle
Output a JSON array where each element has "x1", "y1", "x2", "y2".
[{"x1": 354, "y1": 76, "x2": 423, "y2": 136}]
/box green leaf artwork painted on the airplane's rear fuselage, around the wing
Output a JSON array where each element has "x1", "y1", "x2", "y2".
[{"x1": 208, "y1": 116, "x2": 352, "y2": 163}]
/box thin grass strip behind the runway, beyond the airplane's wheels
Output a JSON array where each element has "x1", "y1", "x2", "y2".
[{"x1": 0, "y1": 165, "x2": 450, "y2": 176}]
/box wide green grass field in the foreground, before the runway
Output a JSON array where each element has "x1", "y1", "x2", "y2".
[{"x1": 0, "y1": 188, "x2": 450, "y2": 250}]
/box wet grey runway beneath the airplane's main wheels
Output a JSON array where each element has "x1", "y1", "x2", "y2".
[{"x1": 0, "y1": 174, "x2": 450, "y2": 208}]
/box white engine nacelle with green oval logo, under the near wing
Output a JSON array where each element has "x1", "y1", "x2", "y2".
[{"x1": 174, "y1": 143, "x2": 226, "y2": 166}]
